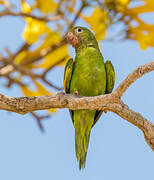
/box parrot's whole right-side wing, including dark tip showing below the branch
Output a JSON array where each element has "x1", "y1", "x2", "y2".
[{"x1": 93, "y1": 61, "x2": 115, "y2": 126}]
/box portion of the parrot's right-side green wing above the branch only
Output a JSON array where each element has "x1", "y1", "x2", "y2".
[{"x1": 105, "y1": 61, "x2": 115, "y2": 94}]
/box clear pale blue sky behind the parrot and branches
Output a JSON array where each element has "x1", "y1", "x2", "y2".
[{"x1": 0, "y1": 0, "x2": 154, "y2": 180}]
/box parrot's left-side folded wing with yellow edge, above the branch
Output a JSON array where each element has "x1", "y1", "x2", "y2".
[{"x1": 64, "y1": 58, "x2": 74, "y2": 93}]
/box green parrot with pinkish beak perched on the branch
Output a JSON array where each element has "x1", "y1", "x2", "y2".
[{"x1": 64, "y1": 26, "x2": 115, "y2": 169}]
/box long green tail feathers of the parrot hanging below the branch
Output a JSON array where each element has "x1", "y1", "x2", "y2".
[{"x1": 74, "y1": 110, "x2": 95, "y2": 170}]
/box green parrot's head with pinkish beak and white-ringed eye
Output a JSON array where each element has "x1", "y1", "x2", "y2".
[{"x1": 66, "y1": 26, "x2": 98, "y2": 48}]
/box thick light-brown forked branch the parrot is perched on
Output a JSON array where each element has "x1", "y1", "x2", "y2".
[{"x1": 0, "y1": 61, "x2": 154, "y2": 151}]
